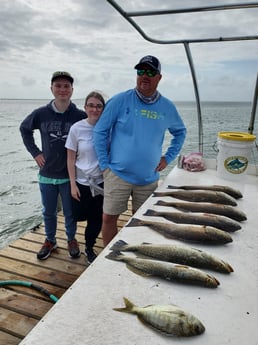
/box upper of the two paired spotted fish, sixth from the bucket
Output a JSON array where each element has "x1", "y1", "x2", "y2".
[{"x1": 110, "y1": 240, "x2": 234, "y2": 273}]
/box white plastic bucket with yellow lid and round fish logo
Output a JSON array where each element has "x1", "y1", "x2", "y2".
[{"x1": 217, "y1": 132, "x2": 256, "y2": 181}]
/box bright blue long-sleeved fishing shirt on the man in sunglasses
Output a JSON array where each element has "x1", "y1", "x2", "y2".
[{"x1": 94, "y1": 89, "x2": 186, "y2": 185}]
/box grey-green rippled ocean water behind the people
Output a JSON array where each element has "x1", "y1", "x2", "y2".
[{"x1": 0, "y1": 99, "x2": 258, "y2": 248}]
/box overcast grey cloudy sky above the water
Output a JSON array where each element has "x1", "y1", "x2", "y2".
[{"x1": 0, "y1": 0, "x2": 258, "y2": 101}]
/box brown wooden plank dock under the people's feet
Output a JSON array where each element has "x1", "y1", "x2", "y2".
[{"x1": 0, "y1": 211, "x2": 131, "y2": 345}]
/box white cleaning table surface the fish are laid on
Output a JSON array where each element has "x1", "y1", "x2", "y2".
[{"x1": 20, "y1": 162, "x2": 258, "y2": 345}]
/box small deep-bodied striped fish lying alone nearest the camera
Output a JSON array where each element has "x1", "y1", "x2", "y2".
[{"x1": 113, "y1": 297, "x2": 205, "y2": 337}]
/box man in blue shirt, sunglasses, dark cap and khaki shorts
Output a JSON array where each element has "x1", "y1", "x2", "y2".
[{"x1": 94, "y1": 55, "x2": 186, "y2": 246}]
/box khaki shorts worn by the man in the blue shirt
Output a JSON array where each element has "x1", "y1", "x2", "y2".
[{"x1": 103, "y1": 169, "x2": 158, "y2": 215}]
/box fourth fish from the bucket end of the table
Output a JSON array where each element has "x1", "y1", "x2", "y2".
[{"x1": 143, "y1": 209, "x2": 241, "y2": 232}]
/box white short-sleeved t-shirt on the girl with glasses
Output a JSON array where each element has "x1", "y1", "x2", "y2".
[{"x1": 65, "y1": 119, "x2": 103, "y2": 185}]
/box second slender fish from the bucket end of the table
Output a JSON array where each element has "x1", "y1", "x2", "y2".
[{"x1": 153, "y1": 190, "x2": 237, "y2": 206}]
